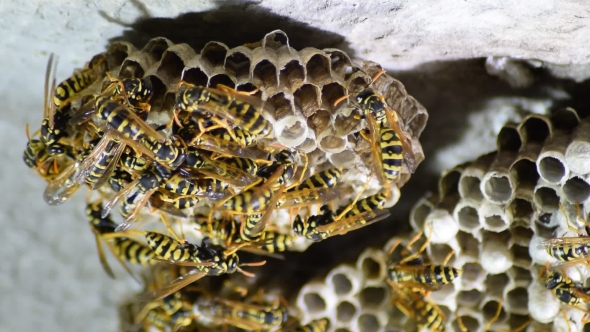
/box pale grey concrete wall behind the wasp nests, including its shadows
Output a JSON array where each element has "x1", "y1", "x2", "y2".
[{"x1": 0, "y1": 0, "x2": 590, "y2": 331}]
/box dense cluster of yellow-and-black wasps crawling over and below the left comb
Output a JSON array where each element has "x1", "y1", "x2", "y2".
[{"x1": 24, "y1": 46, "x2": 415, "y2": 331}]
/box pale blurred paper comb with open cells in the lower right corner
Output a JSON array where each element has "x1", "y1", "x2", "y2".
[{"x1": 298, "y1": 108, "x2": 590, "y2": 331}]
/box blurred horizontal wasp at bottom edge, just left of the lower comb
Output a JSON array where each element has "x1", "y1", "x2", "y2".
[{"x1": 198, "y1": 299, "x2": 288, "y2": 331}]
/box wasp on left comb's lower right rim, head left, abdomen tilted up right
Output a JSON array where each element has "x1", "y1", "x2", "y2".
[{"x1": 293, "y1": 193, "x2": 390, "y2": 242}]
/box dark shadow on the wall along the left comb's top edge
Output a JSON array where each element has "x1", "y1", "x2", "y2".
[{"x1": 100, "y1": 0, "x2": 354, "y2": 57}]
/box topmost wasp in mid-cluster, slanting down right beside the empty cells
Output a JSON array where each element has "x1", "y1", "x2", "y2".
[{"x1": 176, "y1": 82, "x2": 274, "y2": 142}]
